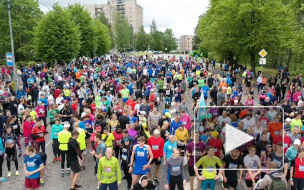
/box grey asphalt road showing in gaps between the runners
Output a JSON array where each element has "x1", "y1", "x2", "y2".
[{"x1": 0, "y1": 62, "x2": 264, "y2": 190}]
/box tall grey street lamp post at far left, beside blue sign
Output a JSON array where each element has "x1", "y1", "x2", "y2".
[{"x1": 4, "y1": 0, "x2": 18, "y2": 92}]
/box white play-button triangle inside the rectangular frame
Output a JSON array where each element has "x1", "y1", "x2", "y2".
[{"x1": 225, "y1": 124, "x2": 253, "y2": 152}]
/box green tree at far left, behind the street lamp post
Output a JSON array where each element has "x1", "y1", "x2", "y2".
[{"x1": 0, "y1": 0, "x2": 43, "y2": 61}]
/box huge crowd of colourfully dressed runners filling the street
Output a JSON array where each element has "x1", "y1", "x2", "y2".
[{"x1": 0, "y1": 55, "x2": 304, "y2": 190}]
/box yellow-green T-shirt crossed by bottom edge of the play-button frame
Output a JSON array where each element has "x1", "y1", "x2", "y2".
[{"x1": 195, "y1": 155, "x2": 222, "y2": 179}]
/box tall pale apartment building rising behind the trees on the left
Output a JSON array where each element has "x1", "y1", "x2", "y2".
[{"x1": 85, "y1": 0, "x2": 144, "y2": 34}]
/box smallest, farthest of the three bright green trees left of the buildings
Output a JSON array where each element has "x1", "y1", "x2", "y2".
[{"x1": 94, "y1": 20, "x2": 112, "y2": 56}]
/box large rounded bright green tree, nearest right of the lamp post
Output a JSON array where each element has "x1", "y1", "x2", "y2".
[{"x1": 34, "y1": 3, "x2": 81, "y2": 63}]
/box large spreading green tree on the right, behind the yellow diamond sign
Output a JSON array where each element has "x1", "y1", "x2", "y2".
[{"x1": 198, "y1": 0, "x2": 303, "y2": 71}]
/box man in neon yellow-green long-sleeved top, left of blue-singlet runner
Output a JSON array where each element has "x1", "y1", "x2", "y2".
[{"x1": 97, "y1": 147, "x2": 121, "y2": 190}]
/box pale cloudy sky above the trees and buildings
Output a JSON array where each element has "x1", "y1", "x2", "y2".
[{"x1": 39, "y1": 0, "x2": 209, "y2": 37}]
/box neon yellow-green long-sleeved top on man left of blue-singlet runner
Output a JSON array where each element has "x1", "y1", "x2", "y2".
[{"x1": 97, "y1": 156, "x2": 121, "y2": 184}]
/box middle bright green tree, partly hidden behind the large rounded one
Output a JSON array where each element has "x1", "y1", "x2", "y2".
[{"x1": 67, "y1": 3, "x2": 96, "y2": 57}]
